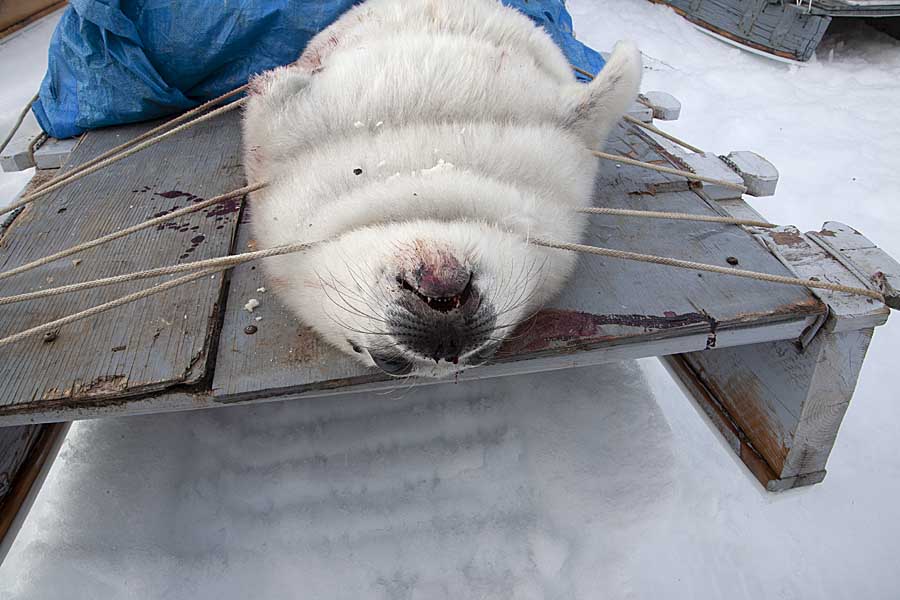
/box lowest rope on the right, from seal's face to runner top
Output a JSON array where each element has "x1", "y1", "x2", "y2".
[{"x1": 529, "y1": 239, "x2": 884, "y2": 302}]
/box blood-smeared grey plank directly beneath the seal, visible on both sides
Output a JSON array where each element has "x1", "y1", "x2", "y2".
[{"x1": 212, "y1": 122, "x2": 825, "y2": 402}]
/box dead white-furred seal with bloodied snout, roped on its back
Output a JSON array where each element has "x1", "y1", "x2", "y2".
[{"x1": 244, "y1": 0, "x2": 641, "y2": 376}]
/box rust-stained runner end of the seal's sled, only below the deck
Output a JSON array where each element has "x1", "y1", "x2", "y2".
[{"x1": 681, "y1": 329, "x2": 872, "y2": 487}]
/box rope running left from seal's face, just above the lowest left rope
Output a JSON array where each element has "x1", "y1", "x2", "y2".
[{"x1": 0, "y1": 242, "x2": 317, "y2": 306}]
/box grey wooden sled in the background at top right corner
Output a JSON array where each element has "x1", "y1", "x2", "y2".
[{"x1": 651, "y1": 0, "x2": 900, "y2": 61}]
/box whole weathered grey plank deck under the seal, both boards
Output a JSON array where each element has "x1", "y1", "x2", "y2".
[{"x1": 0, "y1": 120, "x2": 826, "y2": 425}]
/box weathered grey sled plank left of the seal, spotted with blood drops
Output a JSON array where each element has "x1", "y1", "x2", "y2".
[{"x1": 0, "y1": 114, "x2": 243, "y2": 410}]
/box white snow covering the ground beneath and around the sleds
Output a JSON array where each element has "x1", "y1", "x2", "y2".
[{"x1": 0, "y1": 0, "x2": 900, "y2": 600}]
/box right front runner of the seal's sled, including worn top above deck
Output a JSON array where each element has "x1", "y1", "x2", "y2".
[{"x1": 665, "y1": 227, "x2": 889, "y2": 491}]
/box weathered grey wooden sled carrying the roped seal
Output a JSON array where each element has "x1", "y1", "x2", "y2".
[{"x1": 0, "y1": 94, "x2": 900, "y2": 556}]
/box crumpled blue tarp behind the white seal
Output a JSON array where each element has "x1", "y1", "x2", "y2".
[{"x1": 33, "y1": 0, "x2": 603, "y2": 138}]
